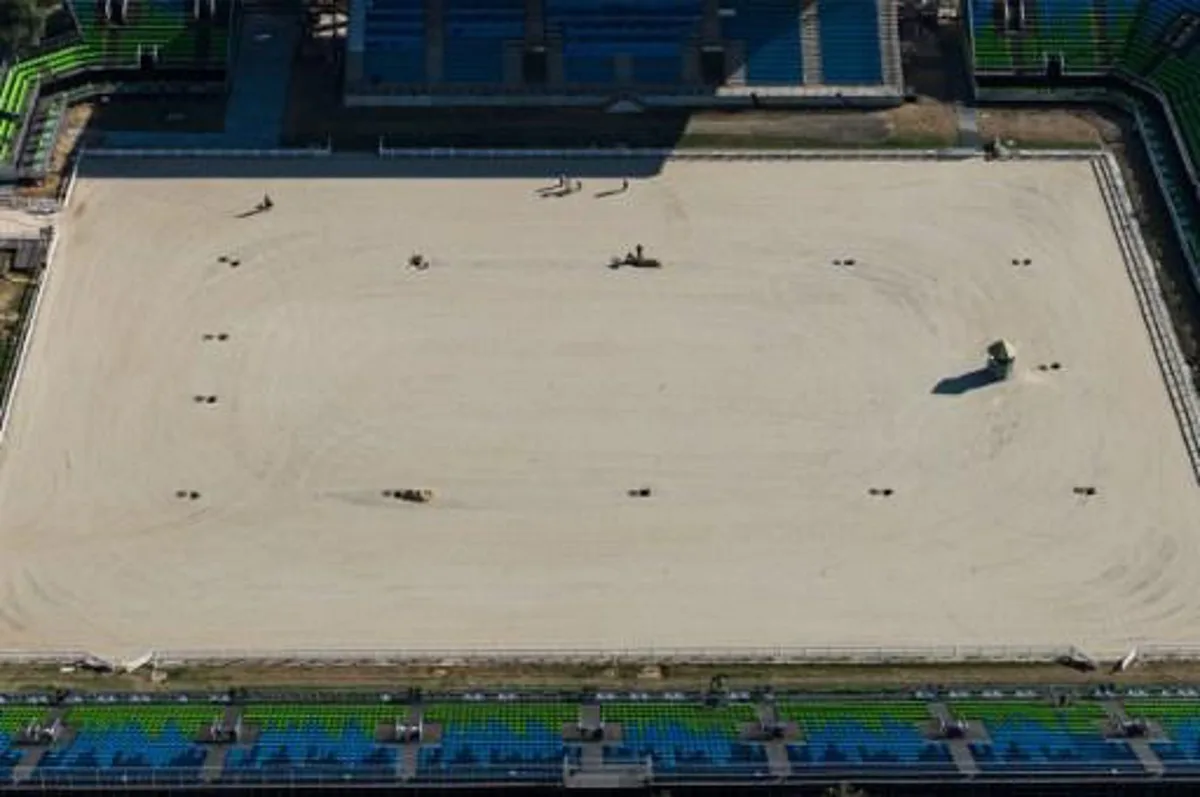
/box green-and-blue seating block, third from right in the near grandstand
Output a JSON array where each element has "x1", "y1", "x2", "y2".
[{"x1": 779, "y1": 700, "x2": 955, "y2": 775}]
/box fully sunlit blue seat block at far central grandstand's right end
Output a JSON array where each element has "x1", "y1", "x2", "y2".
[{"x1": 817, "y1": 0, "x2": 883, "y2": 85}]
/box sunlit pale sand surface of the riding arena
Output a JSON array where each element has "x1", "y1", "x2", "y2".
[{"x1": 0, "y1": 162, "x2": 1200, "y2": 653}]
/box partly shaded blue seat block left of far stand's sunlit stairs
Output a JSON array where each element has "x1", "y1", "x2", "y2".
[{"x1": 721, "y1": 0, "x2": 804, "y2": 86}]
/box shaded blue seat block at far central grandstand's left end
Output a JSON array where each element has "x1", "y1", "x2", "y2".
[{"x1": 362, "y1": 0, "x2": 426, "y2": 83}]
